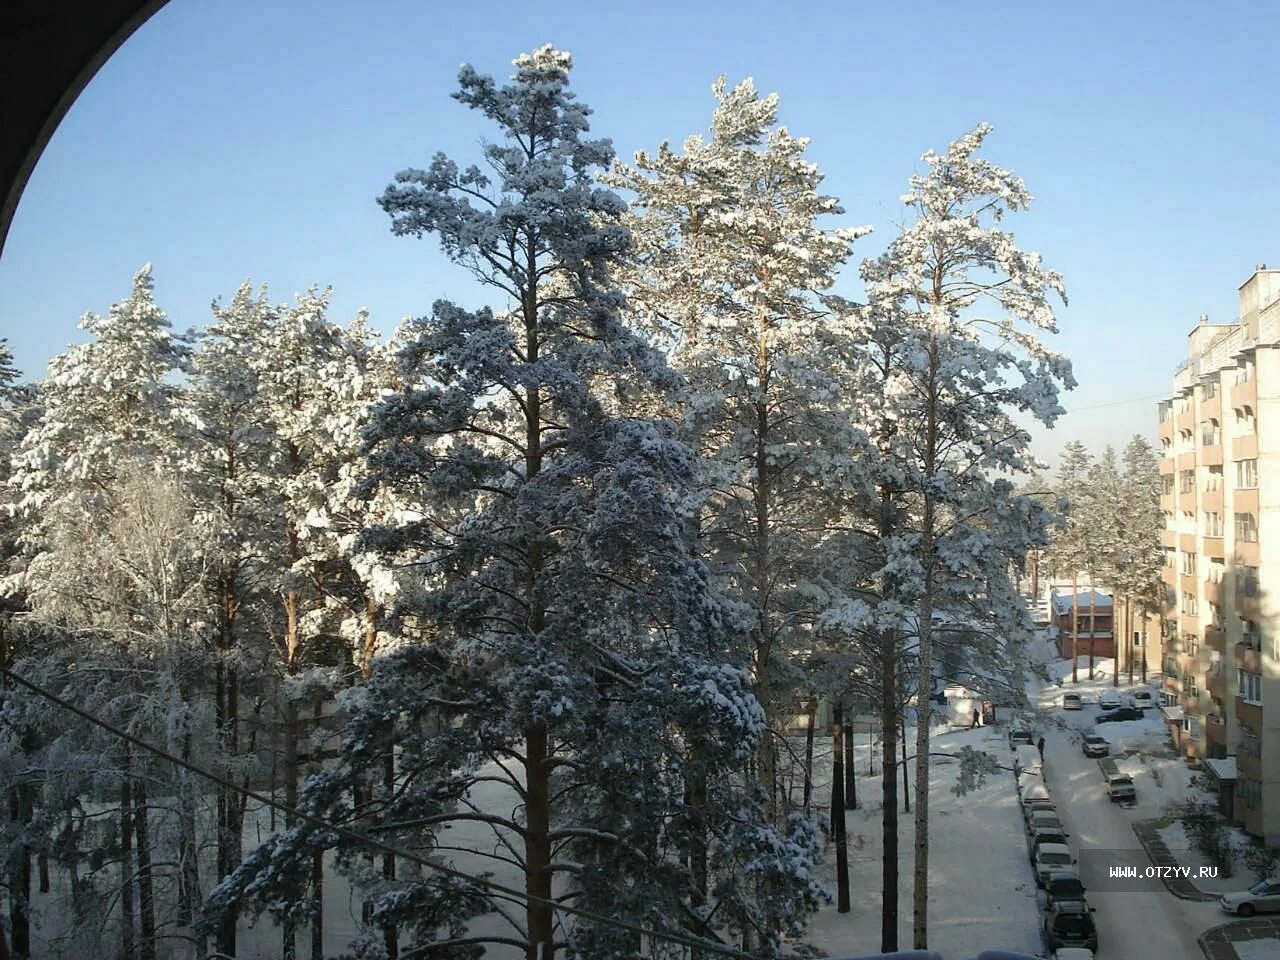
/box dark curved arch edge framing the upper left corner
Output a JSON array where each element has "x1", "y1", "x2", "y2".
[{"x1": 0, "y1": 0, "x2": 168, "y2": 252}]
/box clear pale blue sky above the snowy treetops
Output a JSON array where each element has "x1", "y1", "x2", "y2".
[{"x1": 0, "y1": 0, "x2": 1280, "y2": 458}]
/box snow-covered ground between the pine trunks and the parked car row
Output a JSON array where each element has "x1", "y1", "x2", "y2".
[{"x1": 810, "y1": 727, "x2": 1039, "y2": 959}]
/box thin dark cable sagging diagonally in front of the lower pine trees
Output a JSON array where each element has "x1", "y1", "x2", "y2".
[{"x1": 0, "y1": 667, "x2": 759, "y2": 960}]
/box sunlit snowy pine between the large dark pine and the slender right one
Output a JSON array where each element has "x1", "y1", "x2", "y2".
[{"x1": 607, "y1": 77, "x2": 868, "y2": 834}]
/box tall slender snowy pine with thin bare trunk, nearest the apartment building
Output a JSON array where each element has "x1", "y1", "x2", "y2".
[{"x1": 861, "y1": 124, "x2": 1074, "y2": 950}]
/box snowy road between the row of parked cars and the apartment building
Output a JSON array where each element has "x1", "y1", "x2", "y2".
[{"x1": 1042, "y1": 691, "x2": 1230, "y2": 960}]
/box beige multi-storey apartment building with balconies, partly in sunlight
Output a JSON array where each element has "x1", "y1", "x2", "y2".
[{"x1": 1158, "y1": 265, "x2": 1280, "y2": 844}]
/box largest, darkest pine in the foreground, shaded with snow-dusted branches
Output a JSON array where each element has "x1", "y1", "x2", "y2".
[{"x1": 204, "y1": 46, "x2": 818, "y2": 960}]
